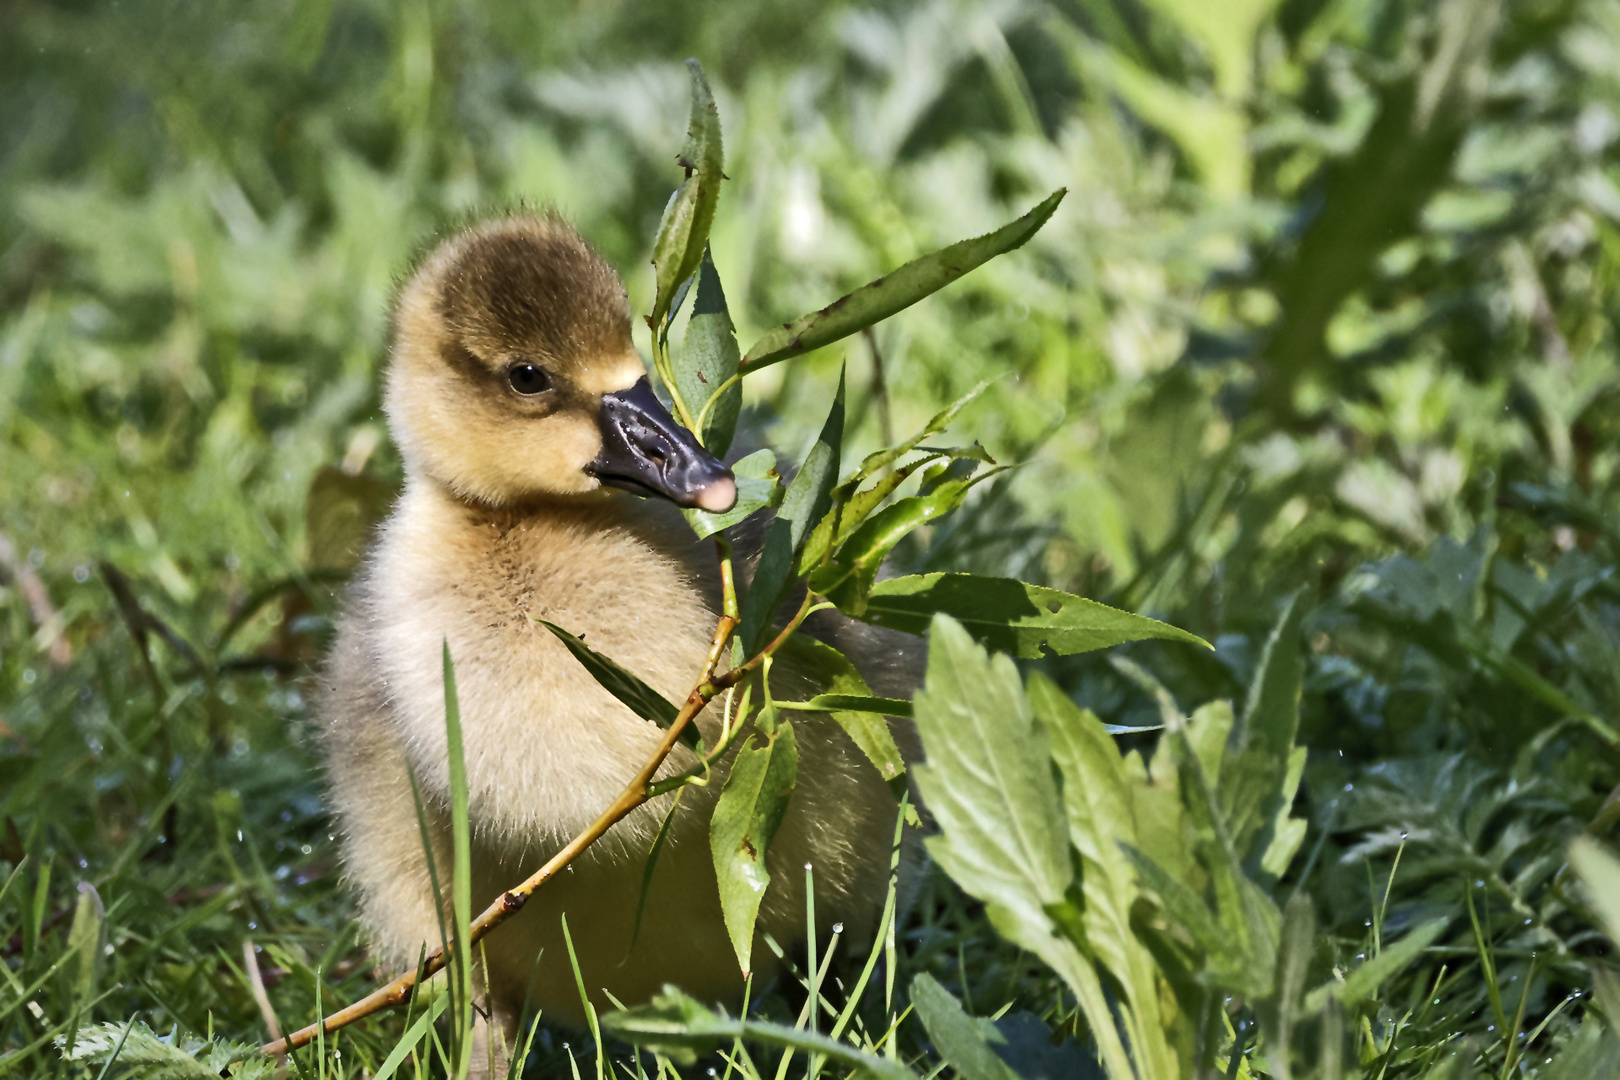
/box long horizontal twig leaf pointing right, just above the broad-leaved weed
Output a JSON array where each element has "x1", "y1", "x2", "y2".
[{"x1": 860, "y1": 573, "x2": 1209, "y2": 659}]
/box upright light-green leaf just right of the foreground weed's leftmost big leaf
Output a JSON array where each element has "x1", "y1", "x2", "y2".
[{"x1": 1029, "y1": 674, "x2": 1178, "y2": 1077}]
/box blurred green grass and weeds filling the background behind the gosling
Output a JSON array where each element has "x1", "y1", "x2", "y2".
[{"x1": 9, "y1": 0, "x2": 1620, "y2": 1075}]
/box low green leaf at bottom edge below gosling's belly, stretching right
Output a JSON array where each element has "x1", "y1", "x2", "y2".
[{"x1": 603, "y1": 986, "x2": 917, "y2": 1080}]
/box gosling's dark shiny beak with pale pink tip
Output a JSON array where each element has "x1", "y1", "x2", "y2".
[{"x1": 590, "y1": 377, "x2": 737, "y2": 513}]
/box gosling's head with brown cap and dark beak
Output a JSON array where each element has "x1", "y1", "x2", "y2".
[{"x1": 384, "y1": 215, "x2": 737, "y2": 512}]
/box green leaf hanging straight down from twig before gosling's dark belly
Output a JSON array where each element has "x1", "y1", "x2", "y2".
[{"x1": 710, "y1": 708, "x2": 799, "y2": 975}]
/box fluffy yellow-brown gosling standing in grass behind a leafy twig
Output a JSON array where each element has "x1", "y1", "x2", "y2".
[{"x1": 318, "y1": 215, "x2": 914, "y2": 1068}]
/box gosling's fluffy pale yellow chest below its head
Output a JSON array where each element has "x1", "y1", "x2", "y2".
[{"x1": 368, "y1": 486, "x2": 714, "y2": 844}]
